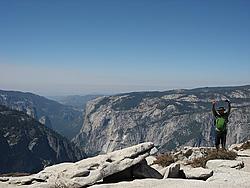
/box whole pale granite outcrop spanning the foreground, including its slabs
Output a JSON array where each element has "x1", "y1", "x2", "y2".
[{"x1": 0, "y1": 143, "x2": 250, "y2": 188}]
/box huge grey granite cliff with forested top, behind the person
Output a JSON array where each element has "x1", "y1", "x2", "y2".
[{"x1": 74, "y1": 86, "x2": 250, "y2": 155}]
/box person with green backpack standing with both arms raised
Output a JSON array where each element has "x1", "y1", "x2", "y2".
[{"x1": 212, "y1": 99, "x2": 231, "y2": 150}]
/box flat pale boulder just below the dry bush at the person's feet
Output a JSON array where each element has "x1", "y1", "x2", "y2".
[{"x1": 206, "y1": 159, "x2": 244, "y2": 171}]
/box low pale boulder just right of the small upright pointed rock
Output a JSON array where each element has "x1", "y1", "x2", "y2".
[{"x1": 183, "y1": 167, "x2": 213, "y2": 180}]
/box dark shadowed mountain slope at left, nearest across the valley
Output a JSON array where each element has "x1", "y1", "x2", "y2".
[{"x1": 0, "y1": 105, "x2": 85, "y2": 173}]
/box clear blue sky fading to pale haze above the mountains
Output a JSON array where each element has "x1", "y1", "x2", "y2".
[{"x1": 0, "y1": 0, "x2": 250, "y2": 95}]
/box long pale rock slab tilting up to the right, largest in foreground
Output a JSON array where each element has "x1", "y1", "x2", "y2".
[{"x1": 0, "y1": 142, "x2": 154, "y2": 188}]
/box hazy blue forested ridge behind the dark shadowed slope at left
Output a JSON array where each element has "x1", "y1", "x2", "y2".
[{"x1": 0, "y1": 90, "x2": 83, "y2": 139}]
